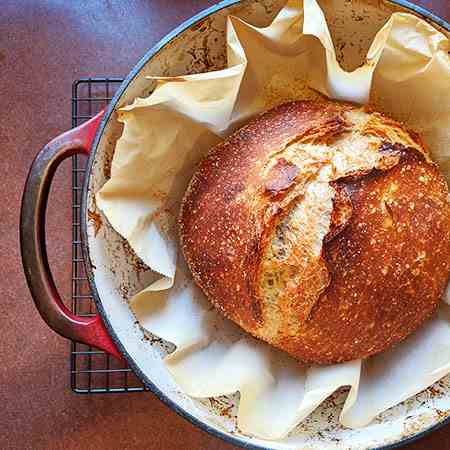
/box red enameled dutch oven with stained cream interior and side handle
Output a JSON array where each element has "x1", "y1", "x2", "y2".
[{"x1": 20, "y1": 0, "x2": 450, "y2": 450}]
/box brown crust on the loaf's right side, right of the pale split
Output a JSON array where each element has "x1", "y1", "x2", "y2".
[{"x1": 282, "y1": 150, "x2": 450, "y2": 363}]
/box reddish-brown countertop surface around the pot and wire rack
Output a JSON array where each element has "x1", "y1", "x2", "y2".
[{"x1": 0, "y1": 0, "x2": 450, "y2": 450}]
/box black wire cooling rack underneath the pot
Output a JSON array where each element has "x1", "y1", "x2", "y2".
[{"x1": 70, "y1": 78, "x2": 146, "y2": 394}]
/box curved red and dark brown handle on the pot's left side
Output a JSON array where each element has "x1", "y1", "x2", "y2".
[{"x1": 20, "y1": 111, "x2": 122, "y2": 359}]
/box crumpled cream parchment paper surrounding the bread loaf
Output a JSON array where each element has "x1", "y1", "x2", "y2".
[{"x1": 96, "y1": 0, "x2": 450, "y2": 439}]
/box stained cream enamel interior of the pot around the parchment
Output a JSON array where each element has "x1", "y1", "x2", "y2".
[{"x1": 82, "y1": 0, "x2": 450, "y2": 449}]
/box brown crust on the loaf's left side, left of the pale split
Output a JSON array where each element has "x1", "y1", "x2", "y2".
[{"x1": 180, "y1": 102, "x2": 342, "y2": 330}]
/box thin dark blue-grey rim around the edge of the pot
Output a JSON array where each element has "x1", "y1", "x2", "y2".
[{"x1": 81, "y1": 0, "x2": 450, "y2": 450}]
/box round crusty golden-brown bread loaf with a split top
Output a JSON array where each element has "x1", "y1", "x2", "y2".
[{"x1": 179, "y1": 101, "x2": 450, "y2": 364}]
